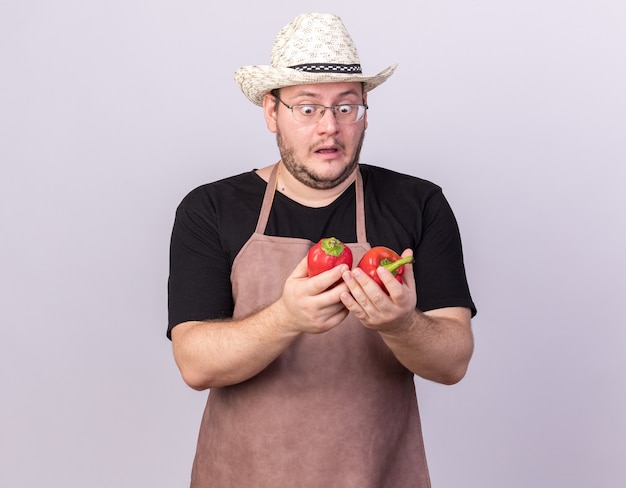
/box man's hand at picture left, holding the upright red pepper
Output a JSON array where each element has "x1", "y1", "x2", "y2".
[{"x1": 277, "y1": 257, "x2": 352, "y2": 334}]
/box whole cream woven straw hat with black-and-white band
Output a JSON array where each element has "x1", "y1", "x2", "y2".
[{"x1": 235, "y1": 13, "x2": 397, "y2": 106}]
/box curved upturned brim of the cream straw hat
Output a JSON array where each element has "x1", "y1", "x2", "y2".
[{"x1": 235, "y1": 64, "x2": 398, "y2": 106}]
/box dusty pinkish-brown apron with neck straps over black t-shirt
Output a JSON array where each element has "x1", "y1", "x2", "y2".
[{"x1": 191, "y1": 168, "x2": 430, "y2": 488}]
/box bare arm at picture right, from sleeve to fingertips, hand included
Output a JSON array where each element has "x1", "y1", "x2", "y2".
[{"x1": 341, "y1": 250, "x2": 474, "y2": 384}]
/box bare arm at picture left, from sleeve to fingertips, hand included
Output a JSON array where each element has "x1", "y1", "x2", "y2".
[{"x1": 172, "y1": 258, "x2": 348, "y2": 390}]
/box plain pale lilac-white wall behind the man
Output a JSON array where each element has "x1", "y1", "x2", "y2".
[{"x1": 0, "y1": 0, "x2": 626, "y2": 488}]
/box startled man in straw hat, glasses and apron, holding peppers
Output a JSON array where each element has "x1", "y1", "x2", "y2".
[{"x1": 168, "y1": 14, "x2": 475, "y2": 488}]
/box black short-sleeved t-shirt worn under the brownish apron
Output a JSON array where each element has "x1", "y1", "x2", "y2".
[{"x1": 168, "y1": 164, "x2": 476, "y2": 337}]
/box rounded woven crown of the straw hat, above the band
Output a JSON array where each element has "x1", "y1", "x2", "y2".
[{"x1": 271, "y1": 13, "x2": 360, "y2": 68}]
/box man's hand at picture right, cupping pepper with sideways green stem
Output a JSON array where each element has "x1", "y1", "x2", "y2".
[{"x1": 340, "y1": 249, "x2": 417, "y2": 332}]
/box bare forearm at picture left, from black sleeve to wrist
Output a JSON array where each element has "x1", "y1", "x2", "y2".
[{"x1": 172, "y1": 304, "x2": 298, "y2": 390}]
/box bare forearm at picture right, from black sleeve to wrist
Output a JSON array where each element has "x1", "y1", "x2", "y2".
[{"x1": 380, "y1": 307, "x2": 474, "y2": 385}]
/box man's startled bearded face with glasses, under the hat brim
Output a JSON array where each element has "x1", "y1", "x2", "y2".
[{"x1": 263, "y1": 83, "x2": 367, "y2": 189}]
